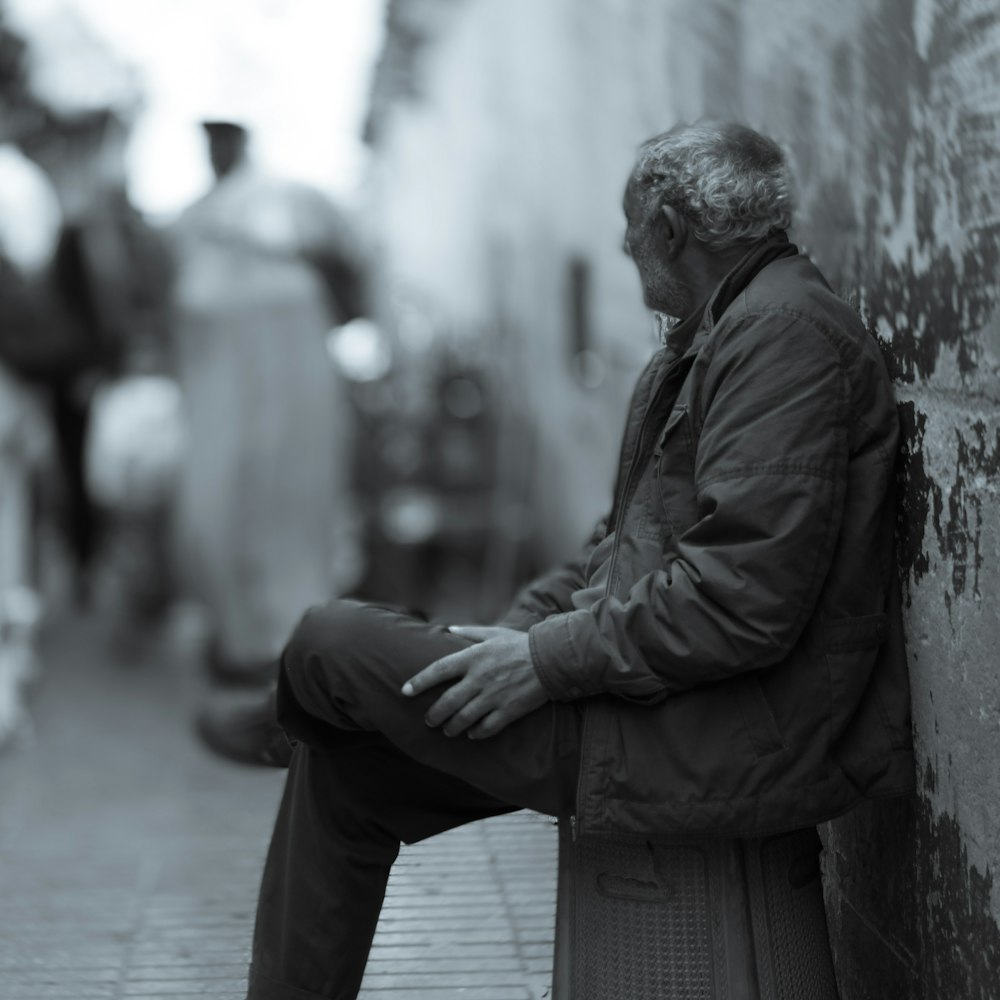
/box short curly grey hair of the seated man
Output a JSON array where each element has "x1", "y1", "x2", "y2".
[{"x1": 632, "y1": 121, "x2": 794, "y2": 250}]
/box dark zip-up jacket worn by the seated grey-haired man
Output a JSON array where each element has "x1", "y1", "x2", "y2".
[{"x1": 504, "y1": 237, "x2": 914, "y2": 836}]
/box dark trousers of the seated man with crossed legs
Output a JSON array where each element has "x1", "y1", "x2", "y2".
[{"x1": 248, "y1": 601, "x2": 582, "y2": 1000}]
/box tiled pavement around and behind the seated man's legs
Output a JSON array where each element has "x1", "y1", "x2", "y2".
[{"x1": 0, "y1": 621, "x2": 556, "y2": 1000}]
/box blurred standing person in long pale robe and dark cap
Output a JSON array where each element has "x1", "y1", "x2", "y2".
[{"x1": 172, "y1": 116, "x2": 365, "y2": 684}]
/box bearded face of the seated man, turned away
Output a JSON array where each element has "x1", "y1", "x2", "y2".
[{"x1": 622, "y1": 178, "x2": 690, "y2": 318}]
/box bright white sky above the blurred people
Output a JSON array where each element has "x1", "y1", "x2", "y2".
[{"x1": 7, "y1": 0, "x2": 384, "y2": 215}]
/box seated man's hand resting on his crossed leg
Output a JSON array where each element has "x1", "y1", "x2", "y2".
[{"x1": 403, "y1": 625, "x2": 549, "y2": 740}]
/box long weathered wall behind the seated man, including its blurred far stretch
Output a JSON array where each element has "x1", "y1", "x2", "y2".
[{"x1": 368, "y1": 0, "x2": 1000, "y2": 1000}]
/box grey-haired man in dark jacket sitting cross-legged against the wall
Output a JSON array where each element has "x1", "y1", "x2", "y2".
[{"x1": 244, "y1": 123, "x2": 913, "y2": 1000}]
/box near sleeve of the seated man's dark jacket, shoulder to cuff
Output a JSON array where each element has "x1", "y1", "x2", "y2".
[{"x1": 529, "y1": 310, "x2": 849, "y2": 703}]
